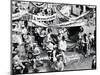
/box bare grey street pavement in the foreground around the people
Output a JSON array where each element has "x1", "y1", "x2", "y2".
[{"x1": 29, "y1": 52, "x2": 92, "y2": 72}]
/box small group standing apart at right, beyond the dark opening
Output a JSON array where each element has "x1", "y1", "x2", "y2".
[{"x1": 78, "y1": 33, "x2": 96, "y2": 56}]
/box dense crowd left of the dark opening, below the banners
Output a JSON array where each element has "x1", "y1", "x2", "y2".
[{"x1": 12, "y1": 21, "x2": 67, "y2": 73}]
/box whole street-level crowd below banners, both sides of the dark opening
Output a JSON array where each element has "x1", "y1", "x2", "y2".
[{"x1": 12, "y1": 20, "x2": 96, "y2": 73}]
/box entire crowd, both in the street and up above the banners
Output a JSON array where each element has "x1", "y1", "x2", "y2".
[{"x1": 12, "y1": 1, "x2": 96, "y2": 74}]
